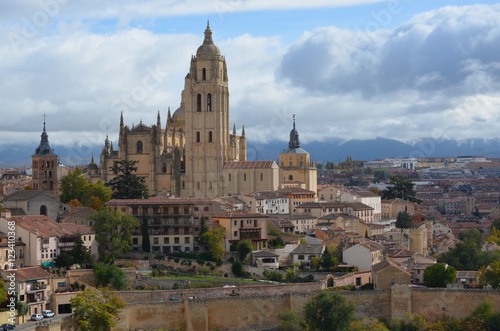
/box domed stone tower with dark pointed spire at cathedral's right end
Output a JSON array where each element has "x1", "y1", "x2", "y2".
[{"x1": 280, "y1": 115, "x2": 318, "y2": 192}]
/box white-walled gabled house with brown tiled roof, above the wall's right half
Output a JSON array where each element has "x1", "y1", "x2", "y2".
[{"x1": 342, "y1": 240, "x2": 384, "y2": 270}]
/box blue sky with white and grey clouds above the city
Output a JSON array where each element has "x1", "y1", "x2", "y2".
[{"x1": 0, "y1": 0, "x2": 500, "y2": 158}]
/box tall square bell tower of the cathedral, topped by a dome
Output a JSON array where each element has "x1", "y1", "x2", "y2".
[{"x1": 181, "y1": 23, "x2": 246, "y2": 198}]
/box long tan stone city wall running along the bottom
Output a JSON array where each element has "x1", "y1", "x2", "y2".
[{"x1": 115, "y1": 283, "x2": 500, "y2": 331}]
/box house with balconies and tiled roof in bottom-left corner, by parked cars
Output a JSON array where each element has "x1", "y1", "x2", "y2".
[{"x1": 1, "y1": 266, "x2": 52, "y2": 315}]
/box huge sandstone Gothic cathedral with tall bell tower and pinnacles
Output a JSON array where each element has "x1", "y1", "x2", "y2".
[{"x1": 99, "y1": 24, "x2": 317, "y2": 198}]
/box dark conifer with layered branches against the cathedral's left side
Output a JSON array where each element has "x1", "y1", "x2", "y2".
[{"x1": 107, "y1": 160, "x2": 149, "y2": 199}]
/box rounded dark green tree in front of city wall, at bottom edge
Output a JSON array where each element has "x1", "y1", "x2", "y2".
[{"x1": 304, "y1": 292, "x2": 356, "y2": 331}]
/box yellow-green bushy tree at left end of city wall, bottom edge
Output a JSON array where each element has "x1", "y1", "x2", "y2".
[{"x1": 70, "y1": 288, "x2": 127, "y2": 331}]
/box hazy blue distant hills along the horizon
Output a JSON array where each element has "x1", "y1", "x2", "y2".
[{"x1": 0, "y1": 138, "x2": 500, "y2": 168}]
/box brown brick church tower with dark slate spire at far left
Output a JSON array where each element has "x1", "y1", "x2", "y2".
[{"x1": 31, "y1": 119, "x2": 59, "y2": 197}]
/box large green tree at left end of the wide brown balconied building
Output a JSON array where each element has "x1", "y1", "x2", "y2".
[{"x1": 89, "y1": 207, "x2": 139, "y2": 263}]
